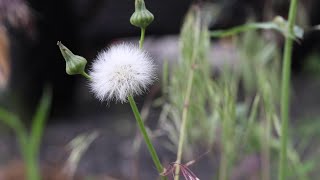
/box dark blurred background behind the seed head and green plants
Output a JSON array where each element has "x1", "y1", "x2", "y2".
[{"x1": 0, "y1": 0, "x2": 320, "y2": 180}]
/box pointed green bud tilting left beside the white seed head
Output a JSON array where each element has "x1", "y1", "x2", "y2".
[{"x1": 57, "y1": 41, "x2": 87, "y2": 75}]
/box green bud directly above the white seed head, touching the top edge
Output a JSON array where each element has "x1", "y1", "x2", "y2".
[{"x1": 130, "y1": 0, "x2": 154, "y2": 28}]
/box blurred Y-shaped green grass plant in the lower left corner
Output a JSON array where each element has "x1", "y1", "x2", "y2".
[{"x1": 0, "y1": 88, "x2": 51, "y2": 180}]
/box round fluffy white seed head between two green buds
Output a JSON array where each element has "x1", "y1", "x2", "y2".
[{"x1": 90, "y1": 43, "x2": 155, "y2": 103}]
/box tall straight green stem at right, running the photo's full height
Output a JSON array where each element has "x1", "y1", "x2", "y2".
[{"x1": 278, "y1": 0, "x2": 298, "y2": 180}]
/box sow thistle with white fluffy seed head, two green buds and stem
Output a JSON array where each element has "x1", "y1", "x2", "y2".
[{"x1": 57, "y1": 0, "x2": 166, "y2": 180}]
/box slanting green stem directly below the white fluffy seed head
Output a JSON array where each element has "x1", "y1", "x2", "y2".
[{"x1": 128, "y1": 95, "x2": 166, "y2": 180}]
